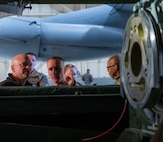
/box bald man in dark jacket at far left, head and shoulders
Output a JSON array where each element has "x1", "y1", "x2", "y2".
[{"x1": 0, "y1": 54, "x2": 32, "y2": 86}]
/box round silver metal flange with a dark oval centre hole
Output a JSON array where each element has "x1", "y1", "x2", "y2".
[{"x1": 121, "y1": 9, "x2": 161, "y2": 108}]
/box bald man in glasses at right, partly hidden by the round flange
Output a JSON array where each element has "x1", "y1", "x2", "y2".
[{"x1": 107, "y1": 55, "x2": 120, "y2": 85}]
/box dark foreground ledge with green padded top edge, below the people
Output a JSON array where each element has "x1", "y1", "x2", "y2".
[{"x1": 0, "y1": 85, "x2": 129, "y2": 142}]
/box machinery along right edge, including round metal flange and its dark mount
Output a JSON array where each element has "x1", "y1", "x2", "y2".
[{"x1": 121, "y1": 0, "x2": 163, "y2": 142}]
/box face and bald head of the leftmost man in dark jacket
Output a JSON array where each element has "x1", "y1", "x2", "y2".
[{"x1": 12, "y1": 56, "x2": 31, "y2": 80}]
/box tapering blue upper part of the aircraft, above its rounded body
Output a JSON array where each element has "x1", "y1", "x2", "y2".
[{"x1": 41, "y1": 4, "x2": 133, "y2": 28}]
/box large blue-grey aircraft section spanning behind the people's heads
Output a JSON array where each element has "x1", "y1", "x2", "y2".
[{"x1": 0, "y1": 5, "x2": 133, "y2": 61}]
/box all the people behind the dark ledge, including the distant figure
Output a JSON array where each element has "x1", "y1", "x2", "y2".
[{"x1": 0, "y1": 53, "x2": 120, "y2": 87}]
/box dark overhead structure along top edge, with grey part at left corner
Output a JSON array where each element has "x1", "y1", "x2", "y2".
[{"x1": 0, "y1": 0, "x2": 139, "y2": 17}]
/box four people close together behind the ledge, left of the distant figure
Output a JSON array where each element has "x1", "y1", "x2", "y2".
[{"x1": 0, "y1": 53, "x2": 80, "y2": 86}]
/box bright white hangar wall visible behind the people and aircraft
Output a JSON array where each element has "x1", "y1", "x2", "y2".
[{"x1": 0, "y1": 4, "x2": 114, "y2": 85}]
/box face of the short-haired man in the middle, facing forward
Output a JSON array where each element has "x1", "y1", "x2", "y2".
[{"x1": 47, "y1": 59, "x2": 63, "y2": 83}]
